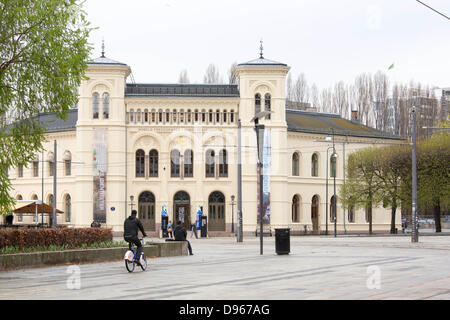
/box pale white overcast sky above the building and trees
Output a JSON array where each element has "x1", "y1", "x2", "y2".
[{"x1": 84, "y1": 0, "x2": 450, "y2": 89}]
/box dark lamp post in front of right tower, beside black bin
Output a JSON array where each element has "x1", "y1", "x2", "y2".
[{"x1": 251, "y1": 111, "x2": 272, "y2": 255}]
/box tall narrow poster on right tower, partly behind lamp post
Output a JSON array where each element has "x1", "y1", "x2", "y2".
[{"x1": 257, "y1": 129, "x2": 271, "y2": 224}]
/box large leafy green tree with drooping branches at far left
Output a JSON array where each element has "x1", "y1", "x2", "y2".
[{"x1": 0, "y1": 0, "x2": 91, "y2": 213}]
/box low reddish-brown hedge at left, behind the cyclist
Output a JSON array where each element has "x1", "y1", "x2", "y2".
[{"x1": 0, "y1": 228, "x2": 112, "y2": 249}]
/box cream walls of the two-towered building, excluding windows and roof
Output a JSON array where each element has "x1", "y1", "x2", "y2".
[{"x1": 6, "y1": 60, "x2": 401, "y2": 235}]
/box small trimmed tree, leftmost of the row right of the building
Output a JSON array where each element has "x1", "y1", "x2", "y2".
[{"x1": 340, "y1": 147, "x2": 382, "y2": 234}]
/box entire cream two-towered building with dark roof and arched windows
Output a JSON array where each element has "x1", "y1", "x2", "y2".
[{"x1": 9, "y1": 55, "x2": 402, "y2": 236}]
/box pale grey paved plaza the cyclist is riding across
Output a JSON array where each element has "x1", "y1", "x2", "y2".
[{"x1": 0, "y1": 236, "x2": 450, "y2": 300}]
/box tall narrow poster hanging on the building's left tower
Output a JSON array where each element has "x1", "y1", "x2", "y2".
[{"x1": 93, "y1": 128, "x2": 107, "y2": 223}]
